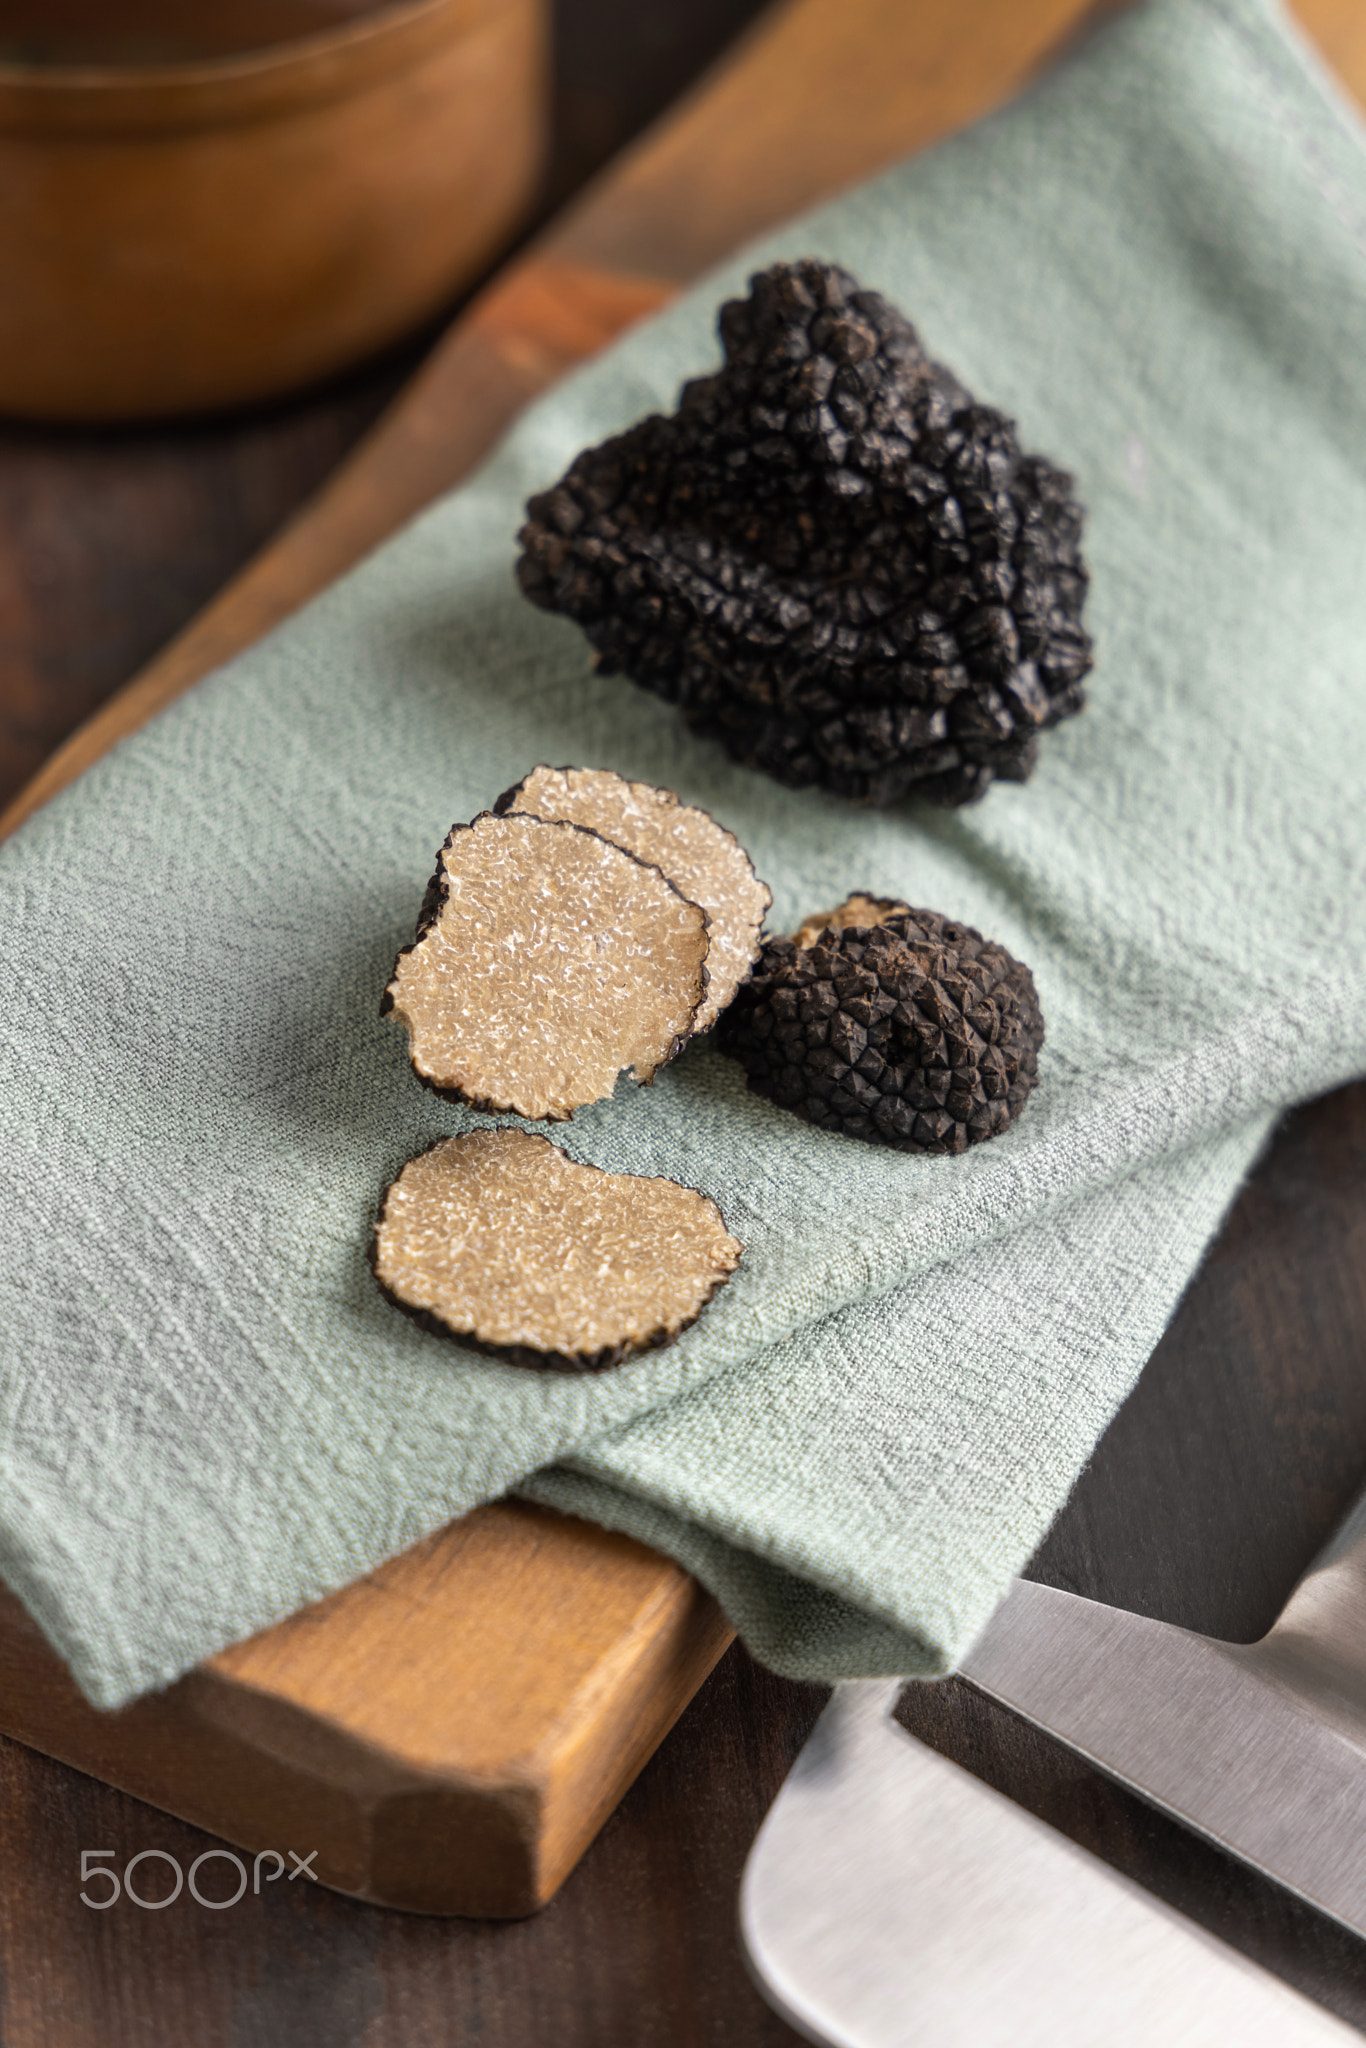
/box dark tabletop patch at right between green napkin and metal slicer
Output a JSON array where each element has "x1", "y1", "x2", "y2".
[{"x1": 1034, "y1": 1081, "x2": 1366, "y2": 1642}]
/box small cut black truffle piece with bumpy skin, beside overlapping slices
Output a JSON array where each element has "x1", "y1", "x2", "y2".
[{"x1": 719, "y1": 895, "x2": 1044, "y2": 1153}]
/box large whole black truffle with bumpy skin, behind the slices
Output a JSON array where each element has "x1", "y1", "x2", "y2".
[{"x1": 518, "y1": 260, "x2": 1092, "y2": 805}]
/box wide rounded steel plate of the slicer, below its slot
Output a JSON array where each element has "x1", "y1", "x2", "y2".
[{"x1": 741, "y1": 1681, "x2": 1360, "y2": 2048}]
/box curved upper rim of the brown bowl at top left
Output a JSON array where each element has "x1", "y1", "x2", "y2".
[{"x1": 0, "y1": 0, "x2": 501, "y2": 133}]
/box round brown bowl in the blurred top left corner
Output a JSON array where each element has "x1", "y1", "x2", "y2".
[{"x1": 0, "y1": 0, "x2": 545, "y2": 420}]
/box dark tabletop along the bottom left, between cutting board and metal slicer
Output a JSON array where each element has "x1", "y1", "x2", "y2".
[{"x1": 0, "y1": 1651, "x2": 823, "y2": 2048}]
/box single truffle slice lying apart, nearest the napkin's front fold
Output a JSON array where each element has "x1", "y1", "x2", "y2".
[{"x1": 373, "y1": 1126, "x2": 743, "y2": 1372}]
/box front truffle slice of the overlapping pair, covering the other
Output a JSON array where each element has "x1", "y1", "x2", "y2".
[{"x1": 383, "y1": 811, "x2": 707, "y2": 1120}]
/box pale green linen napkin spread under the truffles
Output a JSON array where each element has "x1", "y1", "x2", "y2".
[{"x1": 0, "y1": 0, "x2": 1366, "y2": 1706}]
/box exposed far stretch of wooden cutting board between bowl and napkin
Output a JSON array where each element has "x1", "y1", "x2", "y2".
[{"x1": 0, "y1": 0, "x2": 1114, "y2": 836}]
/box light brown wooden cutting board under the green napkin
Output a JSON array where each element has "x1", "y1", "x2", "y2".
[{"x1": 0, "y1": 0, "x2": 1366, "y2": 1917}]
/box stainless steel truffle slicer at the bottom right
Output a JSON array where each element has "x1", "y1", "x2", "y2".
[{"x1": 741, "y1": 1495, "x2": 1366, "y2": 2048}]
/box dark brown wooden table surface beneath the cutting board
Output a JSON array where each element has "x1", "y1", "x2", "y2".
[{"x1": 0, "y1": 0, "x2": 1366, "y2": 2048}]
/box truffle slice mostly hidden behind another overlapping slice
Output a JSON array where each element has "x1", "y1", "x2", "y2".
[{"x1": 494, "y1": 768, "x2": 772, "y2": 1032}]
